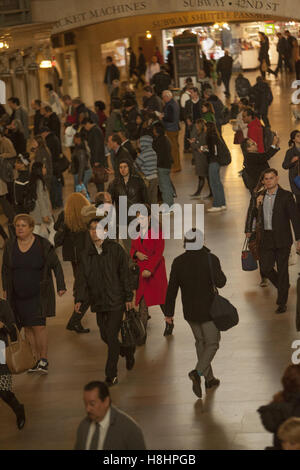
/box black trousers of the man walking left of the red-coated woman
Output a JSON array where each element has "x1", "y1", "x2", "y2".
[{"x1": 97, "y1": 310, "x2": 135, "y2": 379}]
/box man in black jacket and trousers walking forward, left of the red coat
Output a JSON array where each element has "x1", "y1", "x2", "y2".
[{"x1": 75, "y1": 217, "x2": 134, "y2": 386}]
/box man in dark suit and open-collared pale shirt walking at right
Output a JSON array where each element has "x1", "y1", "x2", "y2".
[{"x1": 246, "y1": 168, "x2": 300, "y2": 313}]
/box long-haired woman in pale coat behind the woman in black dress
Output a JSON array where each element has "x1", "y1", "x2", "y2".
[{"x1": 27, "y1": 162, "x2": 55, "y2": 244}]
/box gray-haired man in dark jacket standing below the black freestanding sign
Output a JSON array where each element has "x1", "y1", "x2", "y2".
[{"x1": 160, "y1": 90, "x2": 181, "y2": 172}]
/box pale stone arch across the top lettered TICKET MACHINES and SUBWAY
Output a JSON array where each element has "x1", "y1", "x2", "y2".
[{"x1": 50, "y1": 0, "x2": 300, "y2": 33}]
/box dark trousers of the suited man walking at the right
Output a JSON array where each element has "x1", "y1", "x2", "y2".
[{"x1": 259, "y1": 230, "x2": 291, "y2": 305}]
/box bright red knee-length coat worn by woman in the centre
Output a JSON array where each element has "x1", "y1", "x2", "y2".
[{"x1": 130, "y1": 229, "x2": 168, "y2": 307}]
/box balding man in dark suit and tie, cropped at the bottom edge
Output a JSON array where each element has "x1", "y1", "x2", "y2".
[{"x1": 75, "y1": 382, "x2": 146, "y2": 450}]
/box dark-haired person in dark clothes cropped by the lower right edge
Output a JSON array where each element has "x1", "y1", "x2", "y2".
[{"x1": 257, "y1": 364, "x2": 300, "y2": 450}]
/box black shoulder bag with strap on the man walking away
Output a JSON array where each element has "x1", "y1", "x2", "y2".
[{"x1": 208, "y1": 254, "x2": 239, "y2": 331}]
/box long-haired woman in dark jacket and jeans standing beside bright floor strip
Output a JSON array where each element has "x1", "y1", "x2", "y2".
[{"x1": 206, "y1": 122, "x2": 226, "y2": 212}]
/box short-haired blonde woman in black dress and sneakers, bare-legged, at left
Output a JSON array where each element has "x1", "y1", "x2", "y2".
[{"x1": 2, "y1": 214, "x2": 66, "y2": 374}]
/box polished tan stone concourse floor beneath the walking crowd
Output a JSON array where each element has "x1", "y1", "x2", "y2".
[{"x1": 0, "y1": 73, "x2": 299, "y2": 449}]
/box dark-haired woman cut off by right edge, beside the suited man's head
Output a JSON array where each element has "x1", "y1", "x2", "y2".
[{"x1": 282, "y1": 130, "x2": 300, "y2": 215}]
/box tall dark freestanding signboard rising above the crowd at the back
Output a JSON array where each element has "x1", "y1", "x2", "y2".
[{"x1": 174, "y1": 30, "x2": 201, "y2": 89}]
